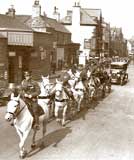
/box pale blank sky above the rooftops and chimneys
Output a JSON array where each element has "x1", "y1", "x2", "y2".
[{"x1": 0, "y1": 0, "x2": 134, "y2": 39}]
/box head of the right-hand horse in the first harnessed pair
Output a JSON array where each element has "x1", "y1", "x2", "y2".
[{"x1": 55, "y1": 79, "x2": 63, "y2": 96}]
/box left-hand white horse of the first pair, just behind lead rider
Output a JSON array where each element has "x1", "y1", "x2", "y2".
[{"x1": 38, "y1": 76, "x2": 53, "y2": 119}]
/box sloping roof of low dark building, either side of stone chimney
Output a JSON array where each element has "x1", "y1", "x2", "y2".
[{"x1": 16, "y1": 15, "x2": 70, "y2": 33}]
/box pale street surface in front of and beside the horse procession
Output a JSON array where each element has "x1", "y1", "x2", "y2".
[{"x1": 0, "y1": 64, "x2": 134, "y2": 160}]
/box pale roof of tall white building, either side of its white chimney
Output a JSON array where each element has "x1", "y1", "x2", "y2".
[{"x1": 61, "y1": 8, "x2": 101, "y2": 26}]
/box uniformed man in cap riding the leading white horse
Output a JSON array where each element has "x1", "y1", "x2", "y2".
[{"x1": 21, "y1": 71, "x2": 40, "y2": 130}]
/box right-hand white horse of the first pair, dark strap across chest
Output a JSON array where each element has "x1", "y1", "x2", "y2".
[{"x1": 51, "y1": 79, "x2": 69, "y2": 126}]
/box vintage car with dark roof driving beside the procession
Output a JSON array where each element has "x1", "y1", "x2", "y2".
[{"x1": 110, "y1": 62, "x2": 128, "y2": 85}]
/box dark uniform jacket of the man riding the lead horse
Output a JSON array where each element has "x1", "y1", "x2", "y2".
[{"x1": 21, "y1": 79, "x2": 40, "y2": 98}]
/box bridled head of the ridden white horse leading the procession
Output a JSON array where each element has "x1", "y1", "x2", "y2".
[{"x1": 5, "y1": 93, "x2": 20, "y2": 122}]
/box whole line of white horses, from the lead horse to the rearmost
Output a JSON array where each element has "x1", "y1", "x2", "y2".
[{"x1": 5, "y1": 70, "x2": 111, "y2": 158}]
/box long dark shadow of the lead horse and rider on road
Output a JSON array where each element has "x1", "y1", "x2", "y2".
[{"x1": 27, "y1": 127, "x2": 72, "y2": 157}]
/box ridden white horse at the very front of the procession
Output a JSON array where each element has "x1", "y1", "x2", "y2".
[{"x1": 5, "y1": 93, "x2": 47, "y2": 158}]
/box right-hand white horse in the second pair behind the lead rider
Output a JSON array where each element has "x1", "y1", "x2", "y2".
[{"x1": 71, "y1": 71, "x2": 86, "y2": 112}]
